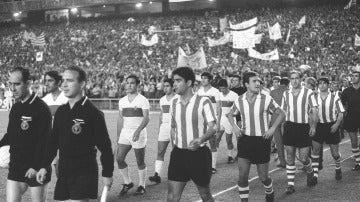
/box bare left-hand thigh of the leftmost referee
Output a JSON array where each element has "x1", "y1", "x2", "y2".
[{"x1": 6, "y1": 180, "x2": 28, "y2": 202}]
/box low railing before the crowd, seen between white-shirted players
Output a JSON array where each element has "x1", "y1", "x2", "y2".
[{"x1": 90, "y1": 98, "x2": 160, "y2": 111}]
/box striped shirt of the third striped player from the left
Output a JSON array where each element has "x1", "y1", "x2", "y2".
[{"x1": 281, "y1": 87, "x2": 318, "y2": 123}]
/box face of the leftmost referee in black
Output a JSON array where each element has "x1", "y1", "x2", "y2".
[{"x1": 9, "y1": 71, "x2": 30, "y2": 100}]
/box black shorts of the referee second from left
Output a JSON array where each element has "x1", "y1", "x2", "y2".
[{"x1": 54, "y1": 173, "x2": 98, "y2": 201}]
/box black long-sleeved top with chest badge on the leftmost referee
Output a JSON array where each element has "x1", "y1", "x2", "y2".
[{"x1": 0, "y1": 93, "x2": 52, "y2": 172}]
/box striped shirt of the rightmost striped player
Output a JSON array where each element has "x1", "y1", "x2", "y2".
[{"x1": 316, "y1": 92, "x2": 345, "y2": 123}]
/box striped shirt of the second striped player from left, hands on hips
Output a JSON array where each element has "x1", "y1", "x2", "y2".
[{"x1": 233, "y1": 92, "x2": 279, "y2": 136}]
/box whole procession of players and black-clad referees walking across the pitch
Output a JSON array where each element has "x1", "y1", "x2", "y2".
[{"x1": 0, "y1": 67, "x2": 360, "y2": 201}]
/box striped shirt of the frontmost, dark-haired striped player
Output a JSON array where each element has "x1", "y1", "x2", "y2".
[{"x1": 170, "y1": 95, "x2": 216, "y2": 149}]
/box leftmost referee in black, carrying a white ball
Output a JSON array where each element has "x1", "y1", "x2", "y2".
[{"x1": 0, "y1": 67, "x2": 51, "y2": 202}]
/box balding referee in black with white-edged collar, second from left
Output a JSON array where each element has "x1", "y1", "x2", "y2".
[{"x1": 37, "y1": 66, "x2": 114, "y2": 201}]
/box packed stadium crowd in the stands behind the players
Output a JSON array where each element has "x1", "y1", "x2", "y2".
[{"x1": 0, "y1": 6, "x2": 360, "y2": 102}]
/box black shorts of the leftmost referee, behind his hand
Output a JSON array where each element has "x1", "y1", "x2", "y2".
[{"x1": 8, "y1": 164, "x2": 51, "y2": 187}]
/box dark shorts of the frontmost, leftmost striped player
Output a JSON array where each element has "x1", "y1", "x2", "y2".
[{"x1": 168, "y1": 146, "x2": 211, "y2": 187}]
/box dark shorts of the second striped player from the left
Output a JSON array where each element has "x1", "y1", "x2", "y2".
[{"x1": 237, "y1": 135, "x2": 271, "y2": 164}]
